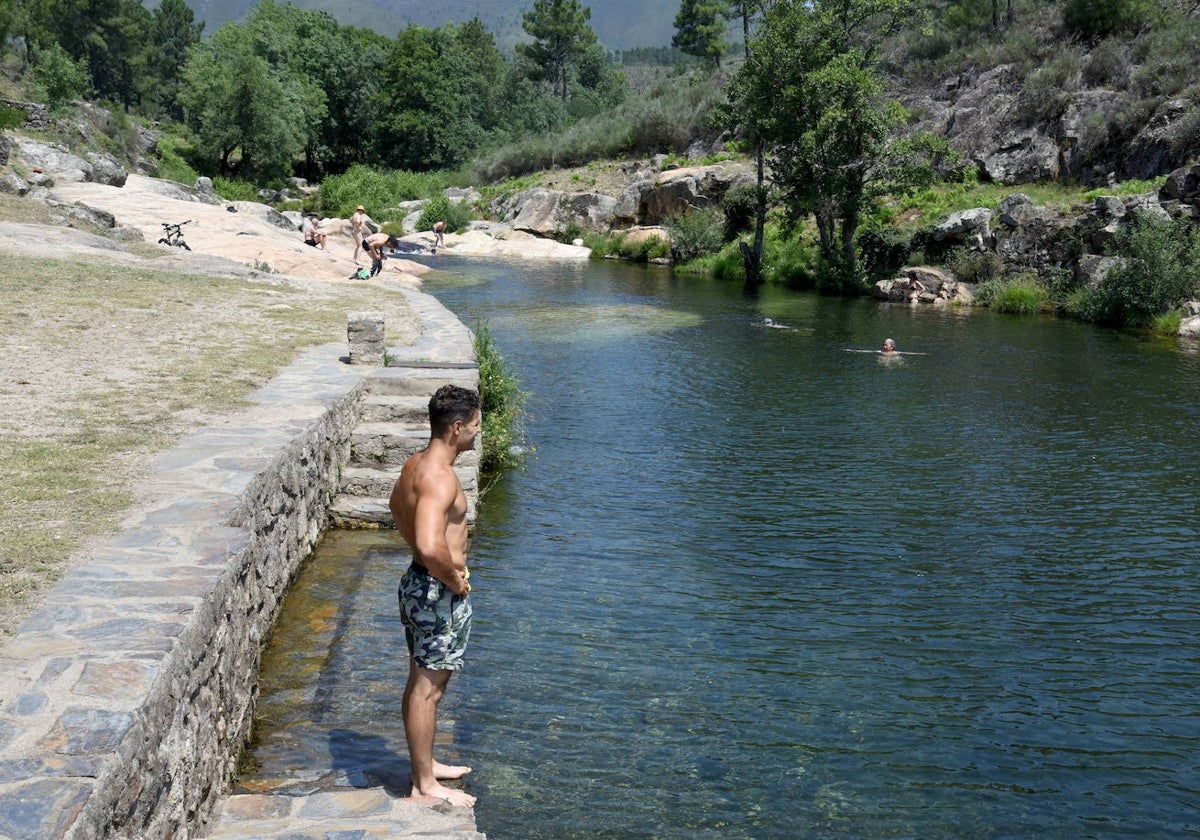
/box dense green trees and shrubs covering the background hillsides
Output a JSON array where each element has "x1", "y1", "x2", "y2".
[{"x1": 0, "y1": 0, "x2": 1200, "y2": 326}]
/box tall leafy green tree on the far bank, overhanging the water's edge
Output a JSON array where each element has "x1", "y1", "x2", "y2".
[{"x1": 732, "y1": 0, "x2": 938, "y2": 287}]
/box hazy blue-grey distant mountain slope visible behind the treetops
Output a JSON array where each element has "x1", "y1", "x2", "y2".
[{"x1": 183, "y1": 0, "x2": 679, "y2": 49}]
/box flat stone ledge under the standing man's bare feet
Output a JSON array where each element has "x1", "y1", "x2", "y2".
[{"x1": 205, "y1": 788, "x2": 485, "y2": 840}]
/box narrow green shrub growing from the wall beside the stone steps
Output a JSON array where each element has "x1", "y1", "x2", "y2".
[{"x1": 474, "y1": 322, "x2": 528, "y2": 475}]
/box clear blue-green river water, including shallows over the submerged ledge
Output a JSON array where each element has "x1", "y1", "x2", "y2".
[{"x1": 241, "y1": 258, "x2": 1200, "y2": 840}]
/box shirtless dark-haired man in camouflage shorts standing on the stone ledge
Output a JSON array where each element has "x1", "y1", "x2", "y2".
[{"x1": 388, "y1": 385, "x2": 480, "y2": 808}]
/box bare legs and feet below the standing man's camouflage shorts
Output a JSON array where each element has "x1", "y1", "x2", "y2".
[{"x1": 402, "y1": 659, "x2": 475, "y2": 808}]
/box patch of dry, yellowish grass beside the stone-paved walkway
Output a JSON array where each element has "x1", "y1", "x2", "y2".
[{"x1": 0, "y1": 253, "x2": 419, "y2": 634}]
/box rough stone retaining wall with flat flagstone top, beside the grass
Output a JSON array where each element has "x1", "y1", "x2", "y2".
[{"x1": 0, "y1": 347, "x2": 366, "y2": 840}]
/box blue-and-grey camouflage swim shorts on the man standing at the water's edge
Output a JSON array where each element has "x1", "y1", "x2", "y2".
[{"x1": 400, "y1": 566, "x2": 472, "y2": 671}]
